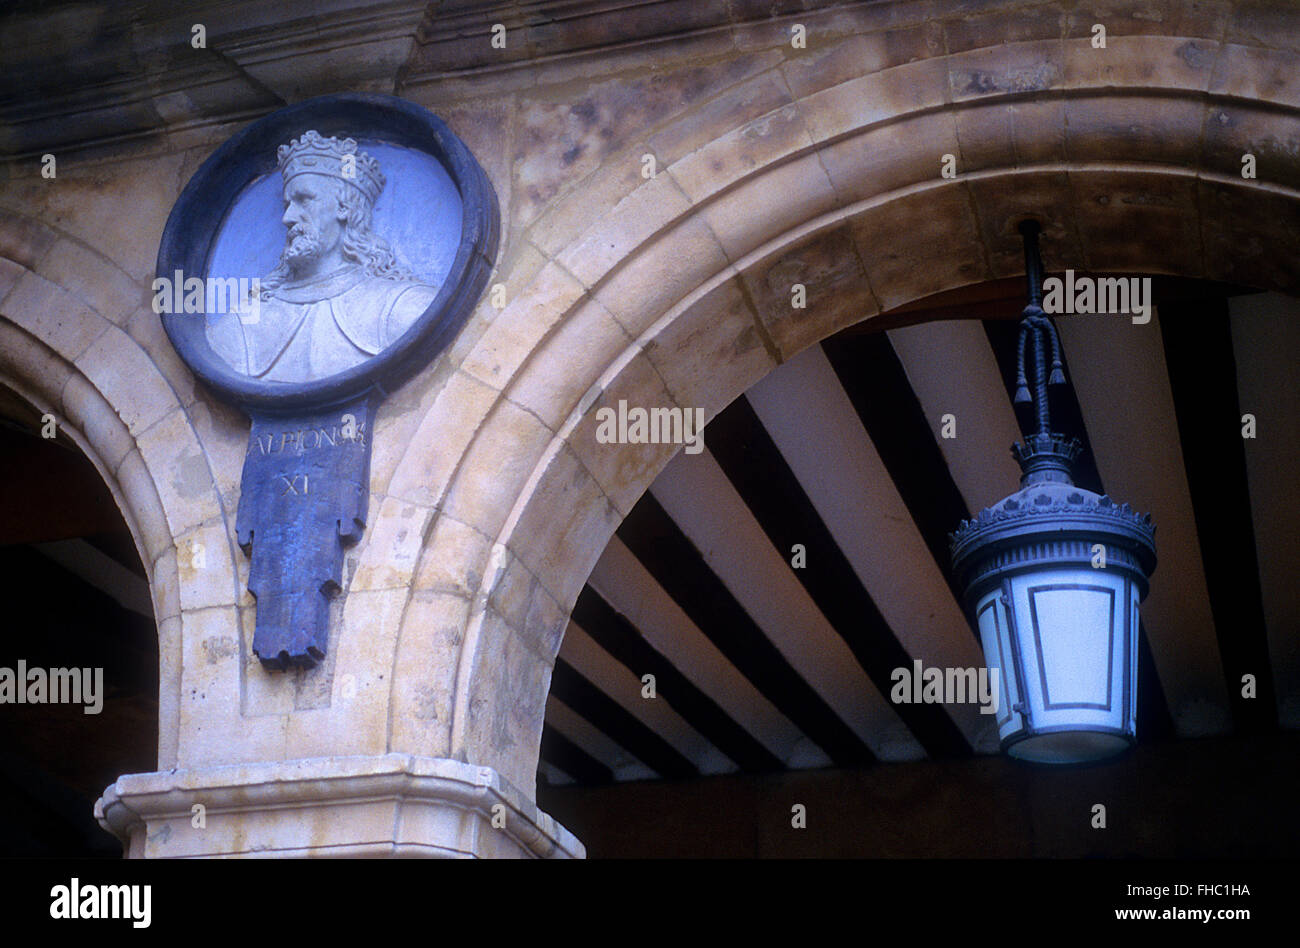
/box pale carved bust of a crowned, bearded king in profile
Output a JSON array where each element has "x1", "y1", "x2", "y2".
[{"x1": 207, "y1": 130, "x2": 438, "y2": 382}]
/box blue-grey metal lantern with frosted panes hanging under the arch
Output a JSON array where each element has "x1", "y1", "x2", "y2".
[{"x1": 950, "y1": 221, "x2": 1156, "y2": 763}]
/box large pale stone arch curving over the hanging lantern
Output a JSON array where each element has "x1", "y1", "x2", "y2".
[{"x1": 361, "y1": 14, "x2": 1300, "y2": 793}]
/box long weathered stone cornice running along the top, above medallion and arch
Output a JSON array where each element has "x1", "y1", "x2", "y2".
[{"x1": 0, "y1": 0, "x2": 852, "y2": 160}]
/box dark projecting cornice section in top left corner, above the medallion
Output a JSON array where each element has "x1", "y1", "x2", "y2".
[{"x1": 0, "y1": 0, "x2": 428, "y2": 159}]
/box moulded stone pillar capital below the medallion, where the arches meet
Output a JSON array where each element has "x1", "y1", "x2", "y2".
[{"x1": 95, "y1": 754, "x2": 586, "y2": 858}]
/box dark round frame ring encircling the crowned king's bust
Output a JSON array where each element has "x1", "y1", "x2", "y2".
[{"x1": 156, "y1": 94, "x2": 501, "y2": 412}]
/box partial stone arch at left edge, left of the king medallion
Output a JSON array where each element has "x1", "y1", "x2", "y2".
[{"x1": 0, "y1": 212, "x2": 239, "y2": 769}]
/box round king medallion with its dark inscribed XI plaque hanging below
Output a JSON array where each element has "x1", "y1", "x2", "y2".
[{"x1": 153, "y1": 95, "x2": 499, "y2": 668}]
